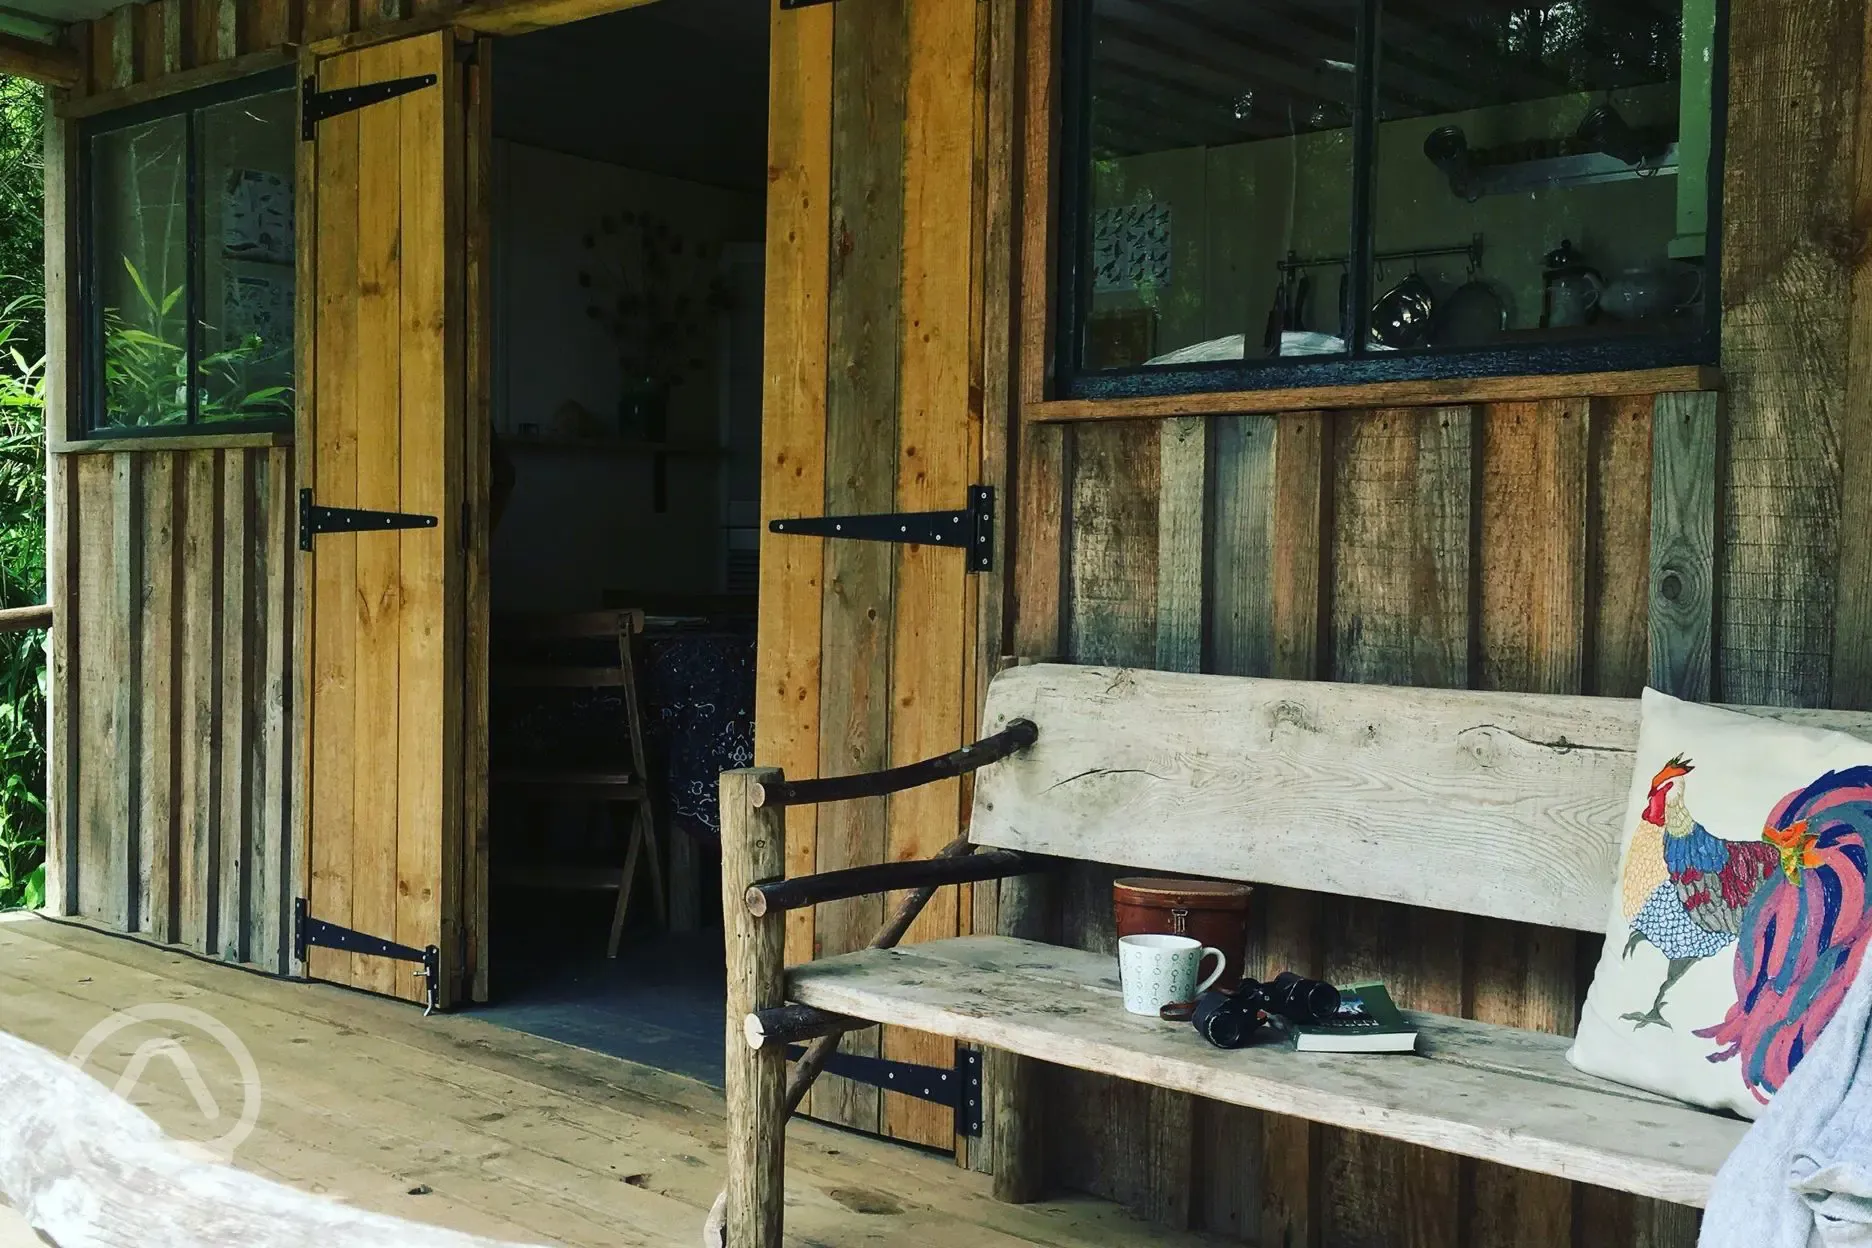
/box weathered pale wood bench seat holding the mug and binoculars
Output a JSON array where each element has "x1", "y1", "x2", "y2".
[{"x1": 786, "y1": 936, "x2": 1748, "y2": 1207}]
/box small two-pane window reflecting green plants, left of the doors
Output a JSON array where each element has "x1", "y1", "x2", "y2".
[{"x1": 79, "y1": 71, "x2": 298, "y2": 436}]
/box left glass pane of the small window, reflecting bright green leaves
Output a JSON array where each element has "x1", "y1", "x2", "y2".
[{"x1": 90, "y1": 118, "x2": 187, "y2": 427}]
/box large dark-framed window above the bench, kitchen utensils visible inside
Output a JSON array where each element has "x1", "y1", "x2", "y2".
[{"x1": 1058, "y1": 0, "x2": 1722, "y2": 399}]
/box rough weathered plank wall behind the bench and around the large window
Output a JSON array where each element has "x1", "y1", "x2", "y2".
[{"x1": 1009, "y1": 0, "x2": 1872, "y2": 1248}]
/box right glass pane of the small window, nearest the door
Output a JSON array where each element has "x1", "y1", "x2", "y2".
[{"x1": 197, "y1": 90, "x2": 296, "y2": 421}]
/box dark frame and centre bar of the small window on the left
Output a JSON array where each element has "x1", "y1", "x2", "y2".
[{"x1": 76, "y1": 65, "x2": 303, "y2": 442}]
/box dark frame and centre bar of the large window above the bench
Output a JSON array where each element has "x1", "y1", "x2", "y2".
[{"x1": 1046, "y1": 0, "x2": 1730, "y2": 400}]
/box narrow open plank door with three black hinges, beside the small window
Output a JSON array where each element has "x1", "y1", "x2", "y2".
[{"x1": 298, "y1": 32, "x2": 470, "y2": 1005}]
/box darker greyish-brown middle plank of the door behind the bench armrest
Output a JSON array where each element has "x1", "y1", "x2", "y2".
[{"x1": 797, "y1": 0, "x2": 910, "y2": 1130}]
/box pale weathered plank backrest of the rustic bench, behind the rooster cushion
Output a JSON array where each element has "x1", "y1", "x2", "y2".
[{"x1": 970, "y1": 664, "x2": 1872, "y2": 932}]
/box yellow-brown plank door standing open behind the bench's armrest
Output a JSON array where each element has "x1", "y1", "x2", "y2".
[{"x1": 754, "y1": 0, "x2": 1000, "y2": 1149}]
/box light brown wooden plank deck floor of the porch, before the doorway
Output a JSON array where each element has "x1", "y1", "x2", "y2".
[{"x1": 0, "y1": 915, "x2": 1217, "y2": 1248}]
